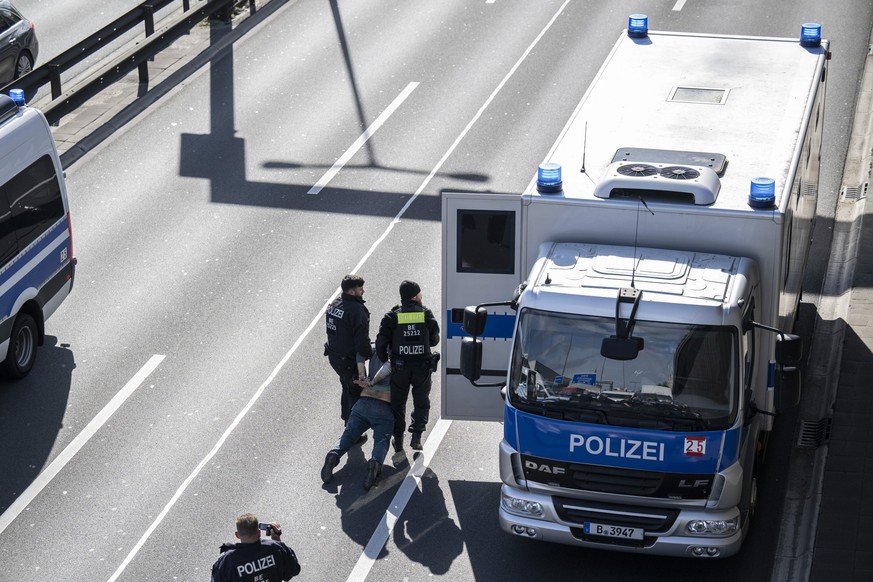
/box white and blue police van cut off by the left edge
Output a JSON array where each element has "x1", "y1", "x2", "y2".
[{"x1": 0, "y1": 89, "x2": 76, "y2": 379}]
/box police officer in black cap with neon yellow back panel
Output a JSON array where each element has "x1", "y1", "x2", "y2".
[{"x1": 376, "y1": 281, "x2": 440, "y2": 451}]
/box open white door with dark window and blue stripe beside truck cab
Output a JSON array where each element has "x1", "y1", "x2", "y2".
[{"x1": 441, "y1": 191, "x2": 524, "y2": 420}]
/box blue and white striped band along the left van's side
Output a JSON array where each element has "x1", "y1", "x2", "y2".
[{"x1": 0, "y1": 216, "x2": 72, "y2": 322}]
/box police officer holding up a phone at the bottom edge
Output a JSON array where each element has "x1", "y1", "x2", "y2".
[{"x1": 212, "y1": 513, "x2": 300, "y2": 582}]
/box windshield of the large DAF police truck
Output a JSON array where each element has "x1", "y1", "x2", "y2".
[{"x1": 508, "y1": 309, "x2": 739, "y2": 431}]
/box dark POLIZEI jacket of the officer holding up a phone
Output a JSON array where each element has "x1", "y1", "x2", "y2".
[{"x1": 212, "y1": 539, "x2": 300, "y2": 582}]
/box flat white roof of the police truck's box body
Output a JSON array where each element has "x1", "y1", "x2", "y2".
[{"x1": 540, "y1": 32, "x2": 827, "y2": 211}]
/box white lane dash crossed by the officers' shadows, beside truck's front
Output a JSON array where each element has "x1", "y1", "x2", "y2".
[{"x1": 346, "y1": 418, "x2": 452, "y2": 582}]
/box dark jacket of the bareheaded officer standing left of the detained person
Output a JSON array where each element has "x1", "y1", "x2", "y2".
[{"x1": 325, "y1": 293, "x2": 373, "y2": 363}]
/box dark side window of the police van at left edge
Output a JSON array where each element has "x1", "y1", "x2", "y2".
[{"x1": 0, "y1": 155, "x2": 64, "y2": 249}]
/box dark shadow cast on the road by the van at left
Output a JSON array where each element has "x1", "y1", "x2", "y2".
[{"x1": 0, "y1": 335, "x2": 76, "y2": 513}]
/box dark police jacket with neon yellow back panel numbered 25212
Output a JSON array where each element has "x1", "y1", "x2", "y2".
[{"x1": 376, "y1": 300, "x2": 440, "y2": 361}]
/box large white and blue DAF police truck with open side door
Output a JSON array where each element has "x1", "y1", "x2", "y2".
[{"x1": 441, "y1": 15, "x2": 829, "y2": 558}]
